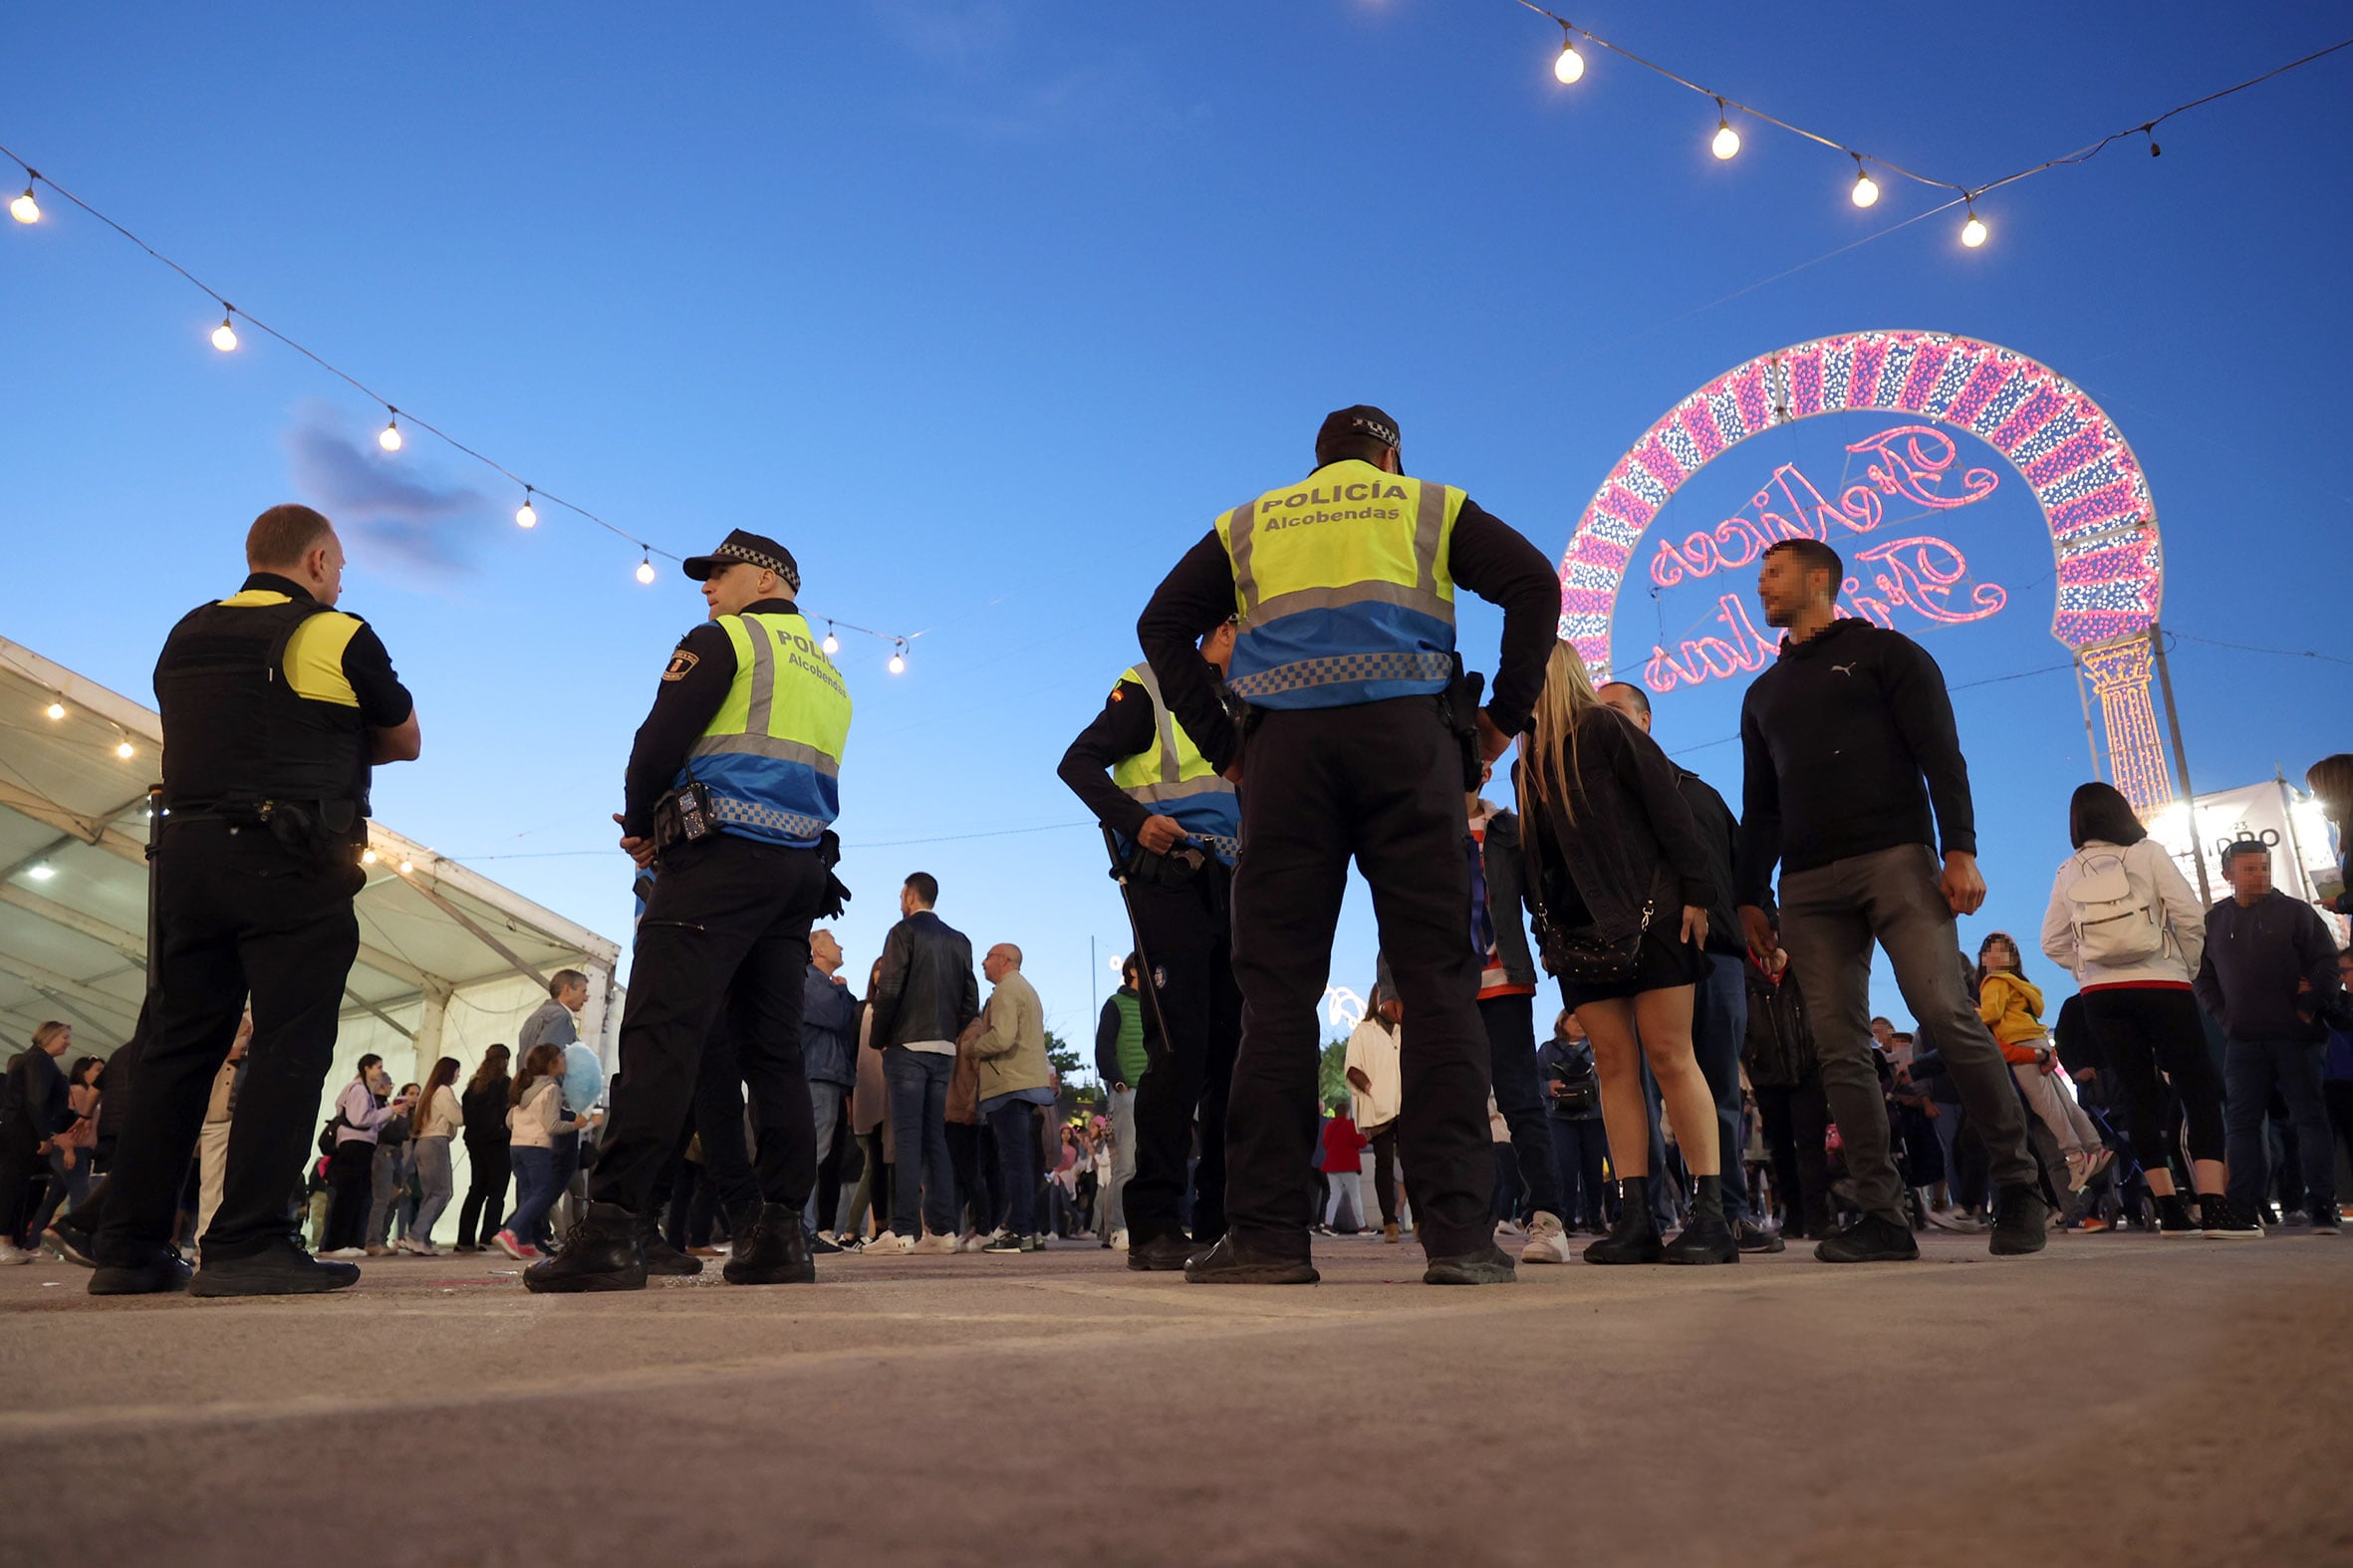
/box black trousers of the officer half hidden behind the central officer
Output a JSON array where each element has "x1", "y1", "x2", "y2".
[{"x1": 1123, "y1": 860, "x2": 1242, "y2": 1245}]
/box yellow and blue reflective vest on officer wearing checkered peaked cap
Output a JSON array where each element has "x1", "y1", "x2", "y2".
[{"x1": 677, "y1": 610, "x2": 850, "y2": 845}]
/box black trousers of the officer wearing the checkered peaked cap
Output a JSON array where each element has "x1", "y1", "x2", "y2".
[{"x1": 589, "y1": 834, "x2": 826, "y2": 1214}]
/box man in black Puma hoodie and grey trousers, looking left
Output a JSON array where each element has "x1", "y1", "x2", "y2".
[{"x1": 1734, "y1": 539, "x2": 2049, "y2": 1262}]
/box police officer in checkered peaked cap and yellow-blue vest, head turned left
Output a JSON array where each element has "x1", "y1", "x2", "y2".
[{"x1": 522, "y1": 530, "x2": 850, "y2": 1292}]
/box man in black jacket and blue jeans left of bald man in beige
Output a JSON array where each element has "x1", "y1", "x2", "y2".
[{"x1": 866, "y1": 871, "x2": 981, "y2": 1252}]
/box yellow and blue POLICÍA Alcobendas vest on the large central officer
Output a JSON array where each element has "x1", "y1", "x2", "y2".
[{"x1": 1216, "y1": 459, "x2": 1463, "y2": 708}]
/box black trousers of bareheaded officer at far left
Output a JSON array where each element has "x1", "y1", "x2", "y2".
[{"x1": 99, "y1": 819, "x2": 365, "y2": 1266}]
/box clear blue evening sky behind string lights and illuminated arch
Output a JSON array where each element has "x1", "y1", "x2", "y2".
[{"x1": 0, "y1": 0, "x2": 2353, "y2": 1036}]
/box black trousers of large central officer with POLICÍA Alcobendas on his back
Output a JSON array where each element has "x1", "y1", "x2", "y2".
[{"x1": 1226, "y1": 697, "x2": 1494, "y2": 1257}]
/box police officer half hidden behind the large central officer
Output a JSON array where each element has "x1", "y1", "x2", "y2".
[{"x1": 1057, "y1": 620, "x2": 1242, "y2": 1269}]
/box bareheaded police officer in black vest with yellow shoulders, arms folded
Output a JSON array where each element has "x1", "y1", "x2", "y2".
[{"x1": 90, "y1": 506, "x2": 418, "y2": 1295}]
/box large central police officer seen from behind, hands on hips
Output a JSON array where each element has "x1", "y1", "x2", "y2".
[{"x1": 1137, "y1": 404, "x2": 1560, "y2": 1285}]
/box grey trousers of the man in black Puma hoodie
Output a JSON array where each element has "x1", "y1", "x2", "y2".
[{"x1": 1781, "y1": 843, "x2": 2037, "y2": 1224}]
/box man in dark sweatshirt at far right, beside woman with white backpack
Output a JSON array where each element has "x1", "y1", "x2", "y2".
[{"x1": 2196, "y1": 838, "x2": 2336, "y2": 1236}]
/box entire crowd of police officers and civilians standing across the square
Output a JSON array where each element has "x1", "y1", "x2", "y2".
[{"x1": 0, "y1": 432, "x2": 2353, "y2": 1295}]
